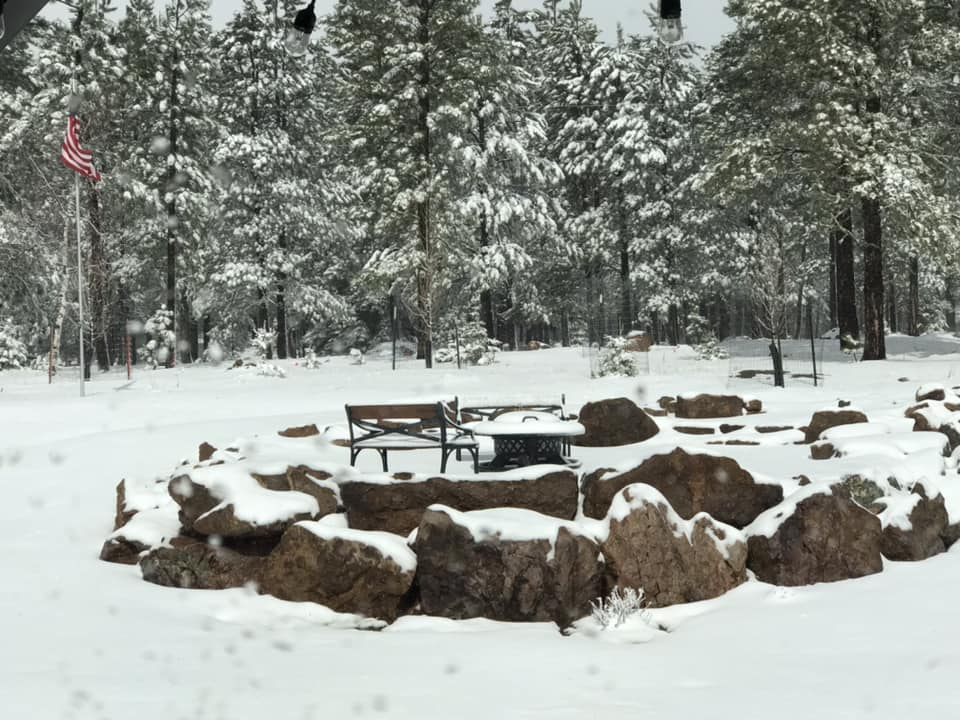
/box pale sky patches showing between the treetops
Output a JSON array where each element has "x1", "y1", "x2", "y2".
[{"x1": 35, "y1": 0, "x2": 733, "y2": 48}]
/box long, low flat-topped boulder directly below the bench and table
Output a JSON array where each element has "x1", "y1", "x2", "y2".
[{"x1": 340, "y1": 468, "x2": 578, "y2": 536}]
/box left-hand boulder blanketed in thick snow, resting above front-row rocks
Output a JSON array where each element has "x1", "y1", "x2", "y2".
[{"x1": 169, "y1": 463, "x2": 326, "y2": 538}]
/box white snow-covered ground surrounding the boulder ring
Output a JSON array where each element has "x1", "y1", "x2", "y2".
[{"x1": 0, "y1": 336, "x2": 960, "y2": 720}]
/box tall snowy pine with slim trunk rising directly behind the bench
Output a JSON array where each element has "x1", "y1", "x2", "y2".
[{"x1": 328, "y1": 0, "x2": 484, "y2": 367}]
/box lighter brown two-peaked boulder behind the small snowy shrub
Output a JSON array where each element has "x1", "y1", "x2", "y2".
[{"x1": 602, "y1": 484, "x2": 747, "y2": 607}]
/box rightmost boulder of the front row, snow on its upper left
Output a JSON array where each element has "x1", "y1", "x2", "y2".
[{"x1": 876, "y1": 483, "x2": 950, "y2": 560}]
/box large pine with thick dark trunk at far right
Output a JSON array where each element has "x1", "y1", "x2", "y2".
[{"x1": 711, "y1": 0, "x2": 957, "y2": 360}]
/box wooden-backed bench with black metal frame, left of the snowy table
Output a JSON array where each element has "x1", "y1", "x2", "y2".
[{"x1": 346, "y1": 400, "x2": 479, "y2": 472}]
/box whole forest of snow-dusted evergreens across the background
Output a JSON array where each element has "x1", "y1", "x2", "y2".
[{"x1": 0, "y1": 0, "x2": 960, "y2": 369}]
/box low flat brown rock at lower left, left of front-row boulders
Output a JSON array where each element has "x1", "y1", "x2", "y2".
[{"x1": 140, "y1": 543, "x2": 263, "y2": 590}]
